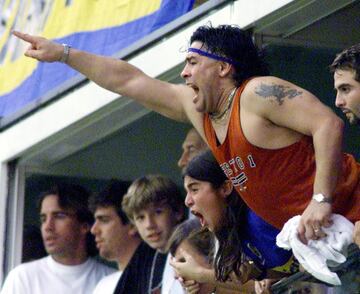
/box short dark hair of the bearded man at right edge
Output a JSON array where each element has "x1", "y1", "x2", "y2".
[{"x1": 330, "y1": 44, "x2": 360, "y2": 82}]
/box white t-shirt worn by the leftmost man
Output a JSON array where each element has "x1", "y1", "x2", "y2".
[{"x1": 0, "y1": 256, "x2": 115, "y2": 294}]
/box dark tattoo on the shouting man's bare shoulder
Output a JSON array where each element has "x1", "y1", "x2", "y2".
[{"x1": 255, "y1": 83, "x2": 302, "y2": 105}]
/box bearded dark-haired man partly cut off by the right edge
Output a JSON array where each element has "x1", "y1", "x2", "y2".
[{"x1": 330, "y1": 44, "x2": 360, "y2": 247}]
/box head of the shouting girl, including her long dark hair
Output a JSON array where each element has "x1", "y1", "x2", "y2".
[{"x1": 184, "y1": 151, "x2": 246, "y2": 281}]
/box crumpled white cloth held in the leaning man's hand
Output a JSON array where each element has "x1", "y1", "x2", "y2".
[{"x1": 276, "y1": 214, "x2": 354, "y2": 285}]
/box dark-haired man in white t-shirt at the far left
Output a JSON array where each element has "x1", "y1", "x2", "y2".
[{"x1": 1, "y1": 185, "x2": 114, "y2": 294}]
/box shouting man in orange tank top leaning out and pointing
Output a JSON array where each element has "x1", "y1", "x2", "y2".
[{"x1": 14, "y1": 25, "x2": 360, "y2": 248}]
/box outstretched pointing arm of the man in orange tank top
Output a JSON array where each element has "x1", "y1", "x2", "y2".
[{"x1": 13, "y1": 31, "x2": 200, "y2": 122}]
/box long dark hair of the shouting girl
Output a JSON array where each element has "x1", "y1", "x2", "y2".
[{"x1": 184, "y1": 151, "x2": 246, "y2": 282}]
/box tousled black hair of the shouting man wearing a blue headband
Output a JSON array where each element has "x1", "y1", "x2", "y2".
[{"x1": 190, "y1": 24, "x2": 269, "y2": 86}]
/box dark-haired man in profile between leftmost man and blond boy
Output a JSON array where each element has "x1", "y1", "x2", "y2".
[{"x1": 90, "y1": 180, "x2": 141, "y2": 294}]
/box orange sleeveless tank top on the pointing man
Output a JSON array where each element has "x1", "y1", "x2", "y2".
[{"x1": 204, "y1": 82, "x2": 360, "y2": 229}]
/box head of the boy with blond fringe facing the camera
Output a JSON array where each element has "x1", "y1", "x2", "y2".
[{"x1": 122, "y1": 175, "x2": 185, "y2": 252}]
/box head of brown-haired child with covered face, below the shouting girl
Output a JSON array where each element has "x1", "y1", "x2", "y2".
[{"x1": 168, "y1": 219, "x2": 214, "y2": 293}]
